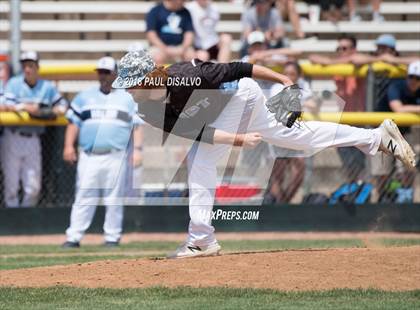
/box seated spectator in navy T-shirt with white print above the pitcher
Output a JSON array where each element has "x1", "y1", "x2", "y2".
[{"x1": 146, "y1": 0, "x2": 194, "y2": 64}]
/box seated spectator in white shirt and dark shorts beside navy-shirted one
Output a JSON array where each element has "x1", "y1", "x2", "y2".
[{"x1": 187, "y1": 0, "x2": 232, "y2": 62}]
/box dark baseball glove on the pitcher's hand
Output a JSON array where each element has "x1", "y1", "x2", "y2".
[{"x1": 265, "y1": 84, "x2": 302, "y2": 128}]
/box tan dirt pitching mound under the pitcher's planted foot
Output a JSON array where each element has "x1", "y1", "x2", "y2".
[{"x1": 0, "y1": 246, "x2": 420, "y2": 291}]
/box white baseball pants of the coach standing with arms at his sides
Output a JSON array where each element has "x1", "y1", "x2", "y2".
[{"x1": 66, "y1": 151, "x2": 127, "y2": 242}]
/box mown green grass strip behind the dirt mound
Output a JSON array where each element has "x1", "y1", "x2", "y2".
[{"x1": 0, "y1": 239, "x2": 420, "y2": 270}]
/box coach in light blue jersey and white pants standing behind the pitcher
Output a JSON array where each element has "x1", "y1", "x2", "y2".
[{"x1": 63, "y1": 57, "x2": 141, "y2": 247}]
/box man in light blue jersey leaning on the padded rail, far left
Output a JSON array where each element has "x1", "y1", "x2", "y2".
[{"x1": 1, "y1": 51, "x2": 67, "y2": 207}]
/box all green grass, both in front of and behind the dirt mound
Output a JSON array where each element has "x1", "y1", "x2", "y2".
[{"x1": 0, "y1": 239, "x2": 420, "y2": 310}]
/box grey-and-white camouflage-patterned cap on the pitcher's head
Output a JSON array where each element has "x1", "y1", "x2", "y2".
[{"x1": 112, "y1": 51, "x2": 156, "y2": 88}]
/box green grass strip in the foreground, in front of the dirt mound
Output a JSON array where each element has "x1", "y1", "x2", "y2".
[{"x1": 0, "y1": 287, "x2": 420, "y2": 310}]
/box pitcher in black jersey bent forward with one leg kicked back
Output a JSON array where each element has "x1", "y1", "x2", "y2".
[{"x1": 112, "y1": 51, "x2": 415, "y2": 258}]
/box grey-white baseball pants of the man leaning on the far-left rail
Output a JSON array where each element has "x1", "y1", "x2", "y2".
[{"x1": 1, "y1": 128, "x2": 42, "y2": 208}]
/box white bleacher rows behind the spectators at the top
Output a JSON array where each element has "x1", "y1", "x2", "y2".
[{"x1": 0, "y1": 1, "x2": 420, "y2": 59}]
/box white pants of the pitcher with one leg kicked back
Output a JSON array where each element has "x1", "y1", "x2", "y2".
[{"x1": 187, "y1": 78, "x2": 381, "y2": 246}]
